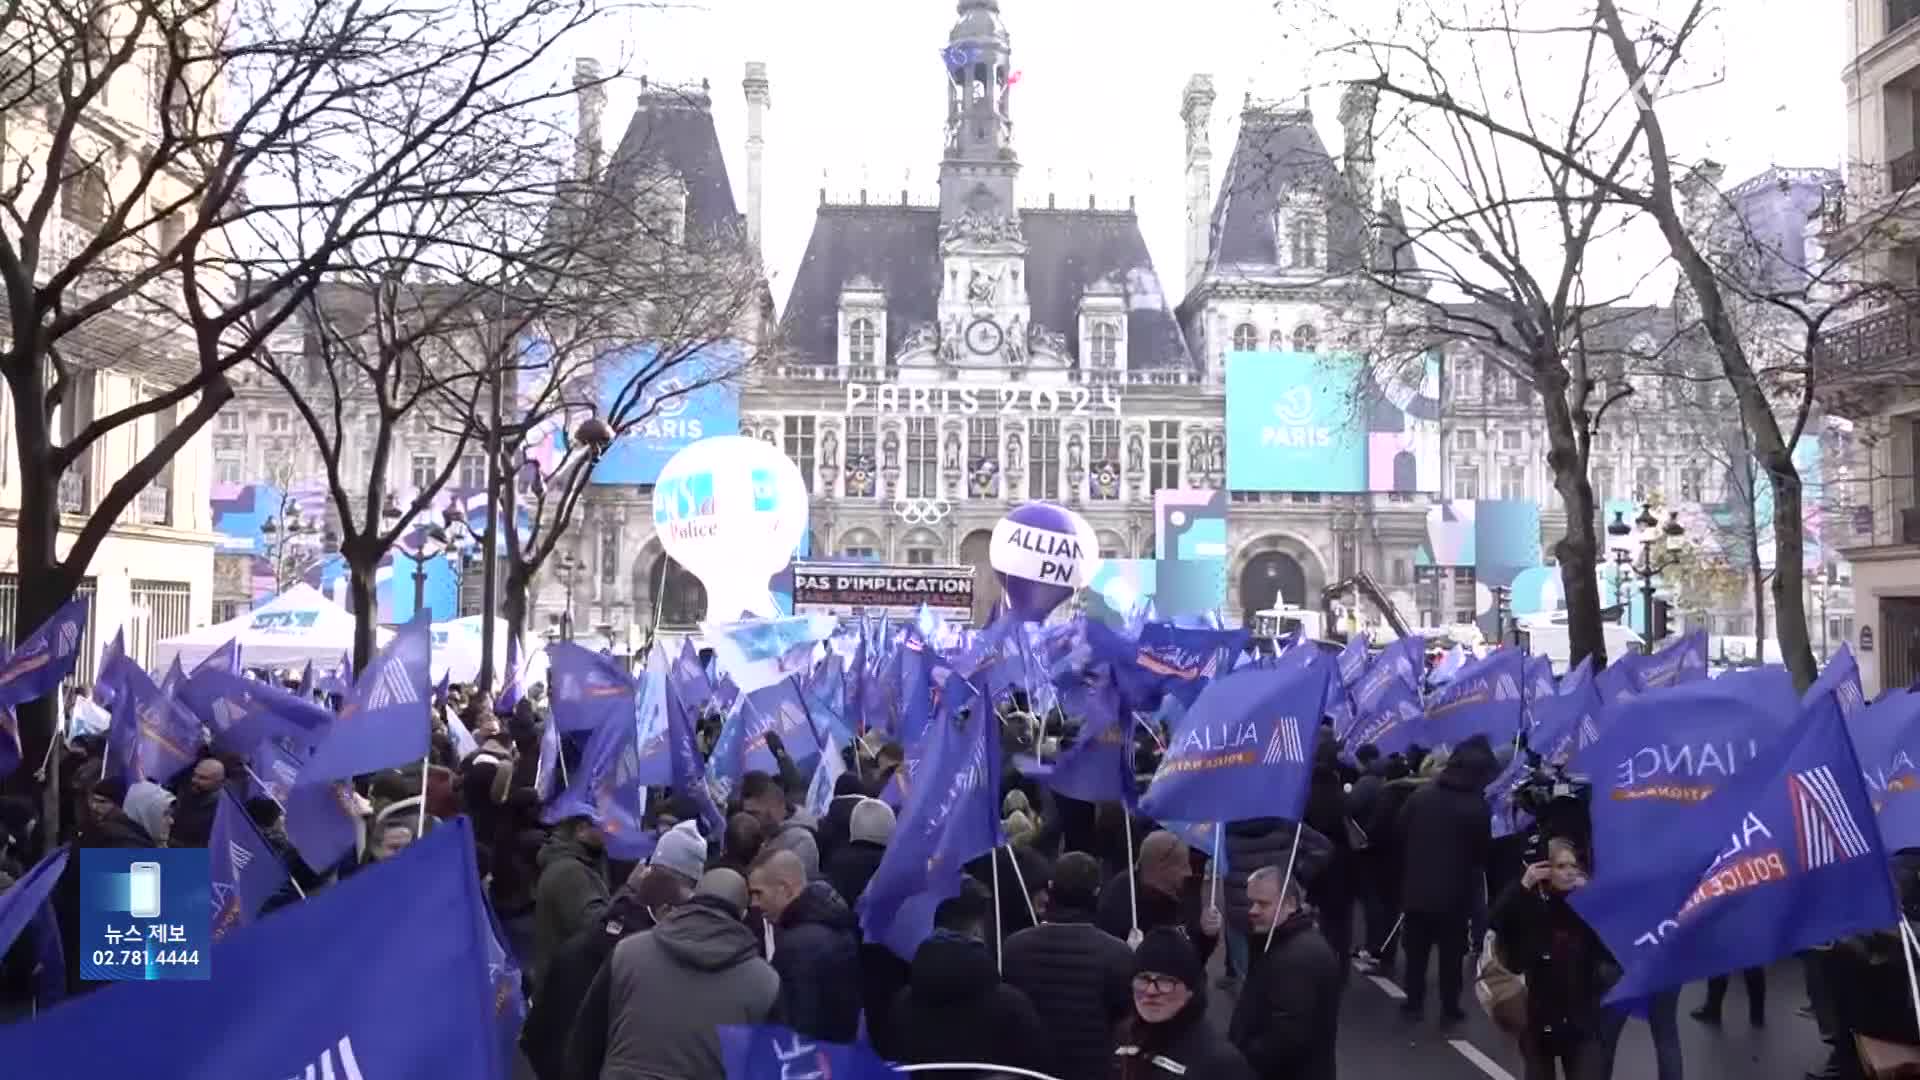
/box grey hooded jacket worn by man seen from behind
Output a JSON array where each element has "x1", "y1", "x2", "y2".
[{"x1": 566, "y1": 896, "x2": 780, "y2": 1080}]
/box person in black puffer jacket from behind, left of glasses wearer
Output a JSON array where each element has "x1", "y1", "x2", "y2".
[{"x1": 1002, "y1": 851, "x2": 1133, "y2": 1080}]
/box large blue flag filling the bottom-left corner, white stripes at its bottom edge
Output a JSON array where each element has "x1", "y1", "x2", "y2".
[{"x1": 0, "y1": 819, "x2": 509, "y2": 1080}]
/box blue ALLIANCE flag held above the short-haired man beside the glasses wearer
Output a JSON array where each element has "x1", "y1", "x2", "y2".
[{"x1": 1140, "y1": 657, "x2": 1334, "y2": 822}]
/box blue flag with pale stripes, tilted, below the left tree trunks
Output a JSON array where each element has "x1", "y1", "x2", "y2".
[{"x1": 300, "y1": 611, "x2": 434, "y2": 782}]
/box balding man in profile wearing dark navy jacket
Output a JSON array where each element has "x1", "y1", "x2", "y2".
[{"x1": 747, "y1": 851, "x2": 860, "y2": 1042}]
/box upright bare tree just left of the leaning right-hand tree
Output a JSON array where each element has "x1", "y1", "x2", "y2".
[{"x1": 1315, "y1": 8, "x2": 1674, "y2": 663}]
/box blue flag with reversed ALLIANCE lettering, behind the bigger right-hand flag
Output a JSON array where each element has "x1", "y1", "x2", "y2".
[{"x1": 1574, "y1": 667, "x2": 1799, "y2": 876}]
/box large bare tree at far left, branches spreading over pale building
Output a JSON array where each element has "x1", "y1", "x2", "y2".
[{"x1": 0, "y1": 0, "x2": 625, "y2": 722}]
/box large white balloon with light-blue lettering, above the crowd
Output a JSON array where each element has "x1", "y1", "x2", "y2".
[{"x1": 653, "y1": 434, "x2": 806, "y2": 621}]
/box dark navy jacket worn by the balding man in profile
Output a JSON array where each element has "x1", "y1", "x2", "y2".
[{"x1": 774, "y1": 882, "x2": 860, "y2": 1042}]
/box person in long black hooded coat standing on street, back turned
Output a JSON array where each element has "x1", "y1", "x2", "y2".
[{"x1": 1396, "y1": 736, "x2": 1494, "y2": 1024}]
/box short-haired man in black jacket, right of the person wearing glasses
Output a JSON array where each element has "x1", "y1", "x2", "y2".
[{"x1": 1227, "y1": 867, "x2": 1346, "y2": 1080}]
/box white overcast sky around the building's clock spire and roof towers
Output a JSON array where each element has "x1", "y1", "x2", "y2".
[{"x1": 579, "y1": 0, "x2": 1847, "y2": 304}]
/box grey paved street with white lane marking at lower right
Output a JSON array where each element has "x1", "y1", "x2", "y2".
[{"x1": 1212, "y1": 949, "x2": 1826, "y2": 1080}]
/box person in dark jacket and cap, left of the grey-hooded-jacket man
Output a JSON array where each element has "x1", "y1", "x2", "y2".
[{"x1": 520, "y1": 865, "x2": 697, "y2": 1080}]
